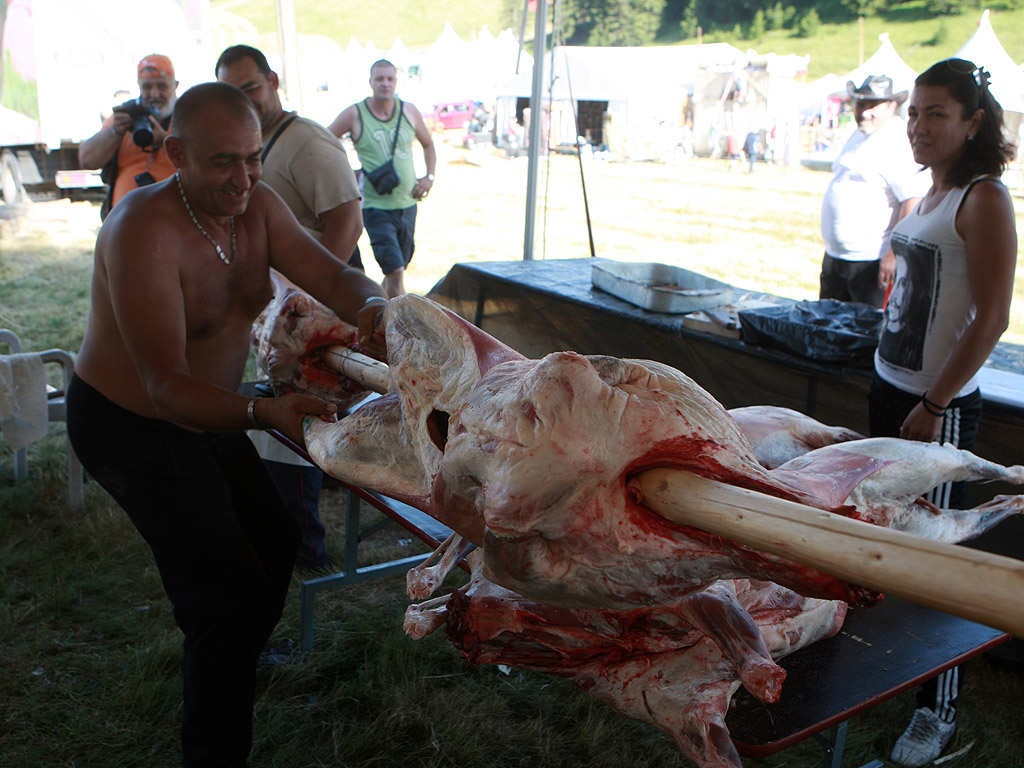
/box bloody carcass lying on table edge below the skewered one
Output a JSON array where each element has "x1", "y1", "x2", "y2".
[{"x1": 406, "y1": 552, "x2": 847, "y2": 768}]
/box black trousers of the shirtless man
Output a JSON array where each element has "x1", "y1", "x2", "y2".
[{"x1": 68, "y1": 376, "x2": 299, "y2": 768}]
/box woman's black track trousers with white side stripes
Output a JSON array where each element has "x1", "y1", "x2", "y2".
[{"x1": 867, "y1": 374, "x2": 982, "y2": 723}]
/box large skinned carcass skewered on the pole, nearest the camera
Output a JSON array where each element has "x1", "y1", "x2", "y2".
[{"x1": 306, "y1": 296, "x2": 877, "y2": 608}]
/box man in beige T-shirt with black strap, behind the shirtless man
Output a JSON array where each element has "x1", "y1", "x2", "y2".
[{"x1": 215, "y1": 45, "x2": 362, "y2": 570}]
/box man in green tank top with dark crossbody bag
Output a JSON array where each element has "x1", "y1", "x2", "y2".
[{"x1": 330, "y1": 58, "x2": 437, "y2": 298}]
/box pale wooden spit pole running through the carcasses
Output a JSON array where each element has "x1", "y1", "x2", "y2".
[{"x1": 324, "y1": 346, "x2": 1024, "y2": 638}]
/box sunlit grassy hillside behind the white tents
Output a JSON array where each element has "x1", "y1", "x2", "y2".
[{"x1": 213, "y1": 0, "x2": 1024, "y2": 79}]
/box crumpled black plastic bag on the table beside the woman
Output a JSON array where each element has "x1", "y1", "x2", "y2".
[{"x1": 738, "y1": 299, "x2": 882, "y2": 368}]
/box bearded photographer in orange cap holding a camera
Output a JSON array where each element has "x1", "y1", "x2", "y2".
[{"x1": 78, "y1": 53, "x2": 178, "y2": 218}]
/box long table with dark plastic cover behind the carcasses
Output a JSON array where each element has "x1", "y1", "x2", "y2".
[{"x1": 428, "y1": 258, "x2": 1024, "y2": 501}]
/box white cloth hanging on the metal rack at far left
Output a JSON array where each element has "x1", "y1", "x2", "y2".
[{"x1": 0, "y1": 353, "x2": 50, "y2": 451}]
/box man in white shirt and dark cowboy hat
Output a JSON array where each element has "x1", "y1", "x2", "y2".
[{"x1": 818, "y1": 75, "x2": 931, "y2": 307}]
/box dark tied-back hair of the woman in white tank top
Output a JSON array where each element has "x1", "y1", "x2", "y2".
[{"x1": 914, "y1": 58, "x2": 1014, "y2": 186}]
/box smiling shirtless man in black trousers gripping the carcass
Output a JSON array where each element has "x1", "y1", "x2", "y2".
[{"x1": 68, "y1": 83, "x2": 385, "y2": 768}]
